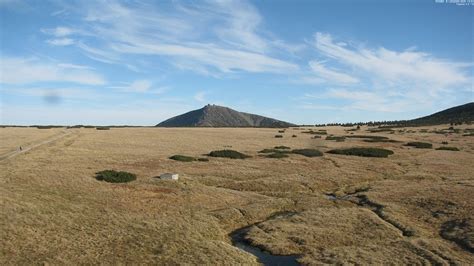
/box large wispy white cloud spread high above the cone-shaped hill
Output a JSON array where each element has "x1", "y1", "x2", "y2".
[{"x1": 46, "y1": 1, "x2": 299, "y2": 74}]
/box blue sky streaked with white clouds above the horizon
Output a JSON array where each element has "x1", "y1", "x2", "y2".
[{"x1": 0, "y1": 0, "x2": 474, "y2": 125}]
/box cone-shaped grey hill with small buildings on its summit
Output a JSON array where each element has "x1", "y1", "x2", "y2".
[{"x1": 156, "y1": 104, "x2": 294, "y2": 127}]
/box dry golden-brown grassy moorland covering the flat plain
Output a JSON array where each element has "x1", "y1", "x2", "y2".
[{"x1": 0, "y1": 125, "x2": 474, "y2": 265}]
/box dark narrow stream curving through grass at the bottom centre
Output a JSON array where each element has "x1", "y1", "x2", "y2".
[{"x1": 230, "y1": 212, "x2": 300, "y2": 266}]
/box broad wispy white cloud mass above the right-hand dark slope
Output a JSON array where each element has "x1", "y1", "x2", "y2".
[{"x1": 298, "y1": 32, "x2": 473, "y2": 112}]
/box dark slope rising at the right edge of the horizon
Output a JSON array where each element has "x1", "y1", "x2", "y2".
[{"x1": 407, "y1": 102, "x2": 474, "y2": 125}]
